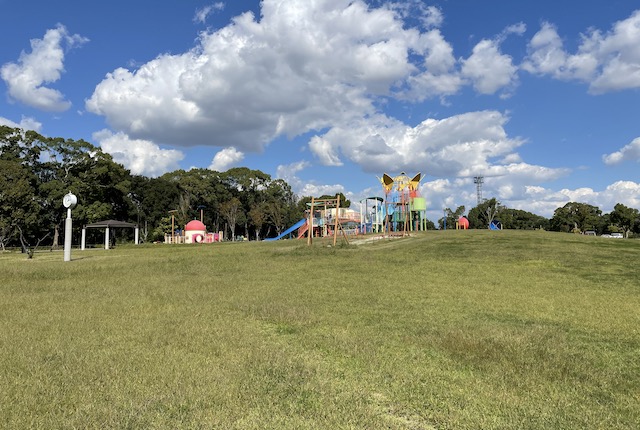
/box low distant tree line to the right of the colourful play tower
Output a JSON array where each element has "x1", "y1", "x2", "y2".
[{"x1": 438, "y1": 198, "x2": 640, "y2": 238}]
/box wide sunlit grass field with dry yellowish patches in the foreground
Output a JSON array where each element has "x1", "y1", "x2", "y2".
[{"x1": 0, "y1": 231, "x2": 640, "y2": 429}]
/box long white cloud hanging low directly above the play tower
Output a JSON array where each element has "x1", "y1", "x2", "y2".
[{"x1": 309, "y1": 111, "x2": 567, "y2": 181}]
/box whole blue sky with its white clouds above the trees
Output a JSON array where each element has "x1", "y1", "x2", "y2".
[{"x1": 0, "y1": 0, "x2": 640, "y2": 221}]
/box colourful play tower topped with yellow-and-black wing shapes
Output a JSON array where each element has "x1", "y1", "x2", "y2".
[{"x1": 379, "y1": 172, "x2": 427, "y2": 236}]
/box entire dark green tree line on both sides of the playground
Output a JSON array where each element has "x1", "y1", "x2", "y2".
[{"x1": 0, "y1": 126, "x2": 640, "y2": 250}]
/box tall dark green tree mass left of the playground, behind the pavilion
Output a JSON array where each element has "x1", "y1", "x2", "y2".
[{"x1": 0, "y1": 126, "x2": 299, "y2": 245}]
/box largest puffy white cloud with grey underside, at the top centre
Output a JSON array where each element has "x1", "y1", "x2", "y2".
[{"x1": 86, "y1": 0, "x2": 523, "y2": 155}]
